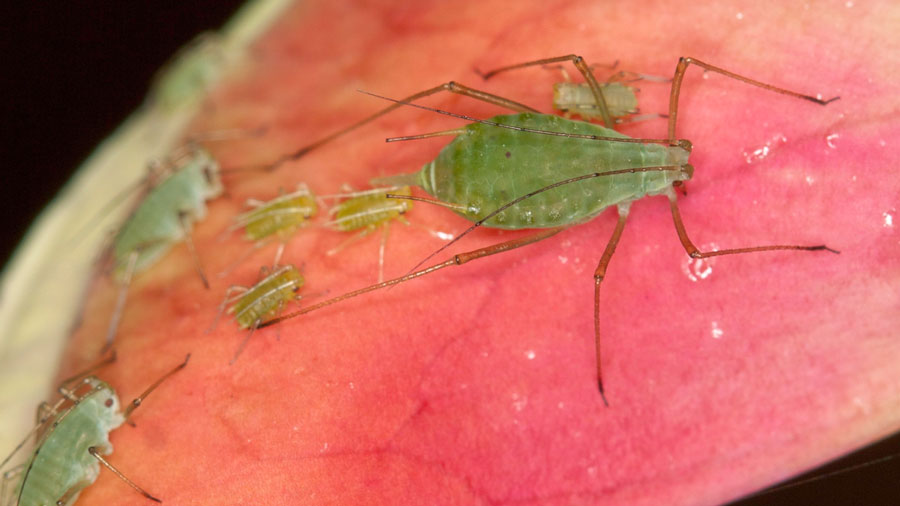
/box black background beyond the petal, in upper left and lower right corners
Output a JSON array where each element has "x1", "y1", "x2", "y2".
[{"x1": 0, "y1": 0, "x2": 900, "y2": 505}]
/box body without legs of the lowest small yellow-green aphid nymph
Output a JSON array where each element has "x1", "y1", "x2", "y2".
[{"x1": 228, "y1": 265, "x2": 304, "y2": 329}]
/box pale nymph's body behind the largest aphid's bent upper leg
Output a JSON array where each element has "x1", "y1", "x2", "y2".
[{"x1": 553, "y1": 82, "x2": 638, "y2": 119}]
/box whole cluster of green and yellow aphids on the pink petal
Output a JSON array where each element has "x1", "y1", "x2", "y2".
[{"x1": 0, "y1": 34, "x2": 834, "y2": 506}]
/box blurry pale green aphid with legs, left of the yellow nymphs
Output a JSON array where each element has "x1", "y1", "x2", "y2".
[{"x1": 104, "y1": 145, "x2": 223, "y2": 350}]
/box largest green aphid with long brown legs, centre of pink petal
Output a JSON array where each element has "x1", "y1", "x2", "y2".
[{"x1": 268, "y1": 55, "x2": 837, "y2": 405}]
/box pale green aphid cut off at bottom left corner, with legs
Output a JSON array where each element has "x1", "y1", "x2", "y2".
[{"x1": 0, "y1": 354, "x2": 190, "y2": 506}]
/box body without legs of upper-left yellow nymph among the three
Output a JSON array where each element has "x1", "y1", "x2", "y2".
[{"x1": 239, "y1": 192, "x2": 318, "y2": 241}]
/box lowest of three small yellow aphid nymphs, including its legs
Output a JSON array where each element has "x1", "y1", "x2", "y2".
[{"x1": 210, "y1": 265, "x2": 305, "y2": 364}]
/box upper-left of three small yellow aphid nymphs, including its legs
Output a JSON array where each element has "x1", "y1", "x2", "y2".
[{"x1": 220, "y1": 183, "x2": 319, "y2": 276}]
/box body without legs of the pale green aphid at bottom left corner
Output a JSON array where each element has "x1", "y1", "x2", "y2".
[{"x1": 17, "y1": 384, "x2": 125, "y2": 506}]
